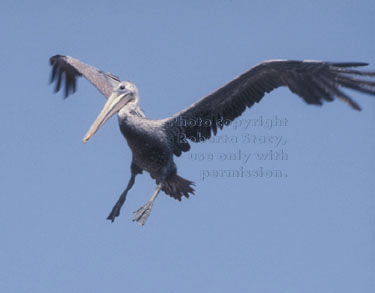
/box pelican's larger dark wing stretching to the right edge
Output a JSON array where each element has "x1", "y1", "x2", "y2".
[{"x1": 164, "y1": 60, "x2": 375, "y2": 156}]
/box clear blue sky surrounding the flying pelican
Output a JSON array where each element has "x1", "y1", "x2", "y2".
[{"x1": 0, "y1": 0, "x2": 375, "y2": 293}]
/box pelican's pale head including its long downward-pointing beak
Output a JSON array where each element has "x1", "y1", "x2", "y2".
[{"x1": 83, "y1": 81, "x2": 138, "y2": 143}]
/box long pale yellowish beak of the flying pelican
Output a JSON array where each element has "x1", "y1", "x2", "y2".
[{"x1": 83, "y1": 92, "x2": 130, "y2": 143}]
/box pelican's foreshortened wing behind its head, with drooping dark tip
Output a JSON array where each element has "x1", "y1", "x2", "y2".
[{"x1": 49, "y1": 55, "x2": 120, "y2": 99}]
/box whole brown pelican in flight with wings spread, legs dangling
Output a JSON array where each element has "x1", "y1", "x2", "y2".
[{"x1": 50, "y1": 55, "x2": 375, "y2": 225}]
